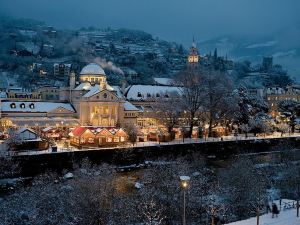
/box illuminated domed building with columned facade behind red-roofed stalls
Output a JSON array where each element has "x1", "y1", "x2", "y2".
[{"x1": 60, "y1": 63, "x2": 138, "y2": 127}]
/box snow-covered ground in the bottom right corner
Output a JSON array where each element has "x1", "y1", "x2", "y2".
[{"x1": 228, "y1": 199, "x2": 300, "y2": 225}]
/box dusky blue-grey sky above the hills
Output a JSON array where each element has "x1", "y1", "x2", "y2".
[{"x1": 0, "y1": 0, "x2": 300, "y2": 45}]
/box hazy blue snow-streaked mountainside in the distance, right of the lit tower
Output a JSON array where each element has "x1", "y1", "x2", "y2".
[{"x1": 198, "y1": 26, "x2": 300, "y2": 81}]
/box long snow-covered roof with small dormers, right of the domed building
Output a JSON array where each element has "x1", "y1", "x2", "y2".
[{"x1": 126, "y1": 85, "x2": 180, "y2": 100}]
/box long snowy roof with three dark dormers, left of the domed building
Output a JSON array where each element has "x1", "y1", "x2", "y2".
[{"x1": 1, "y1": 101, "x2": 75, "y2": 112}]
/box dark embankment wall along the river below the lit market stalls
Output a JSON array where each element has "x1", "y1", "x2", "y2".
[{"x1": 6, "y1": 137, "x2": 300, "y2": 176}]
